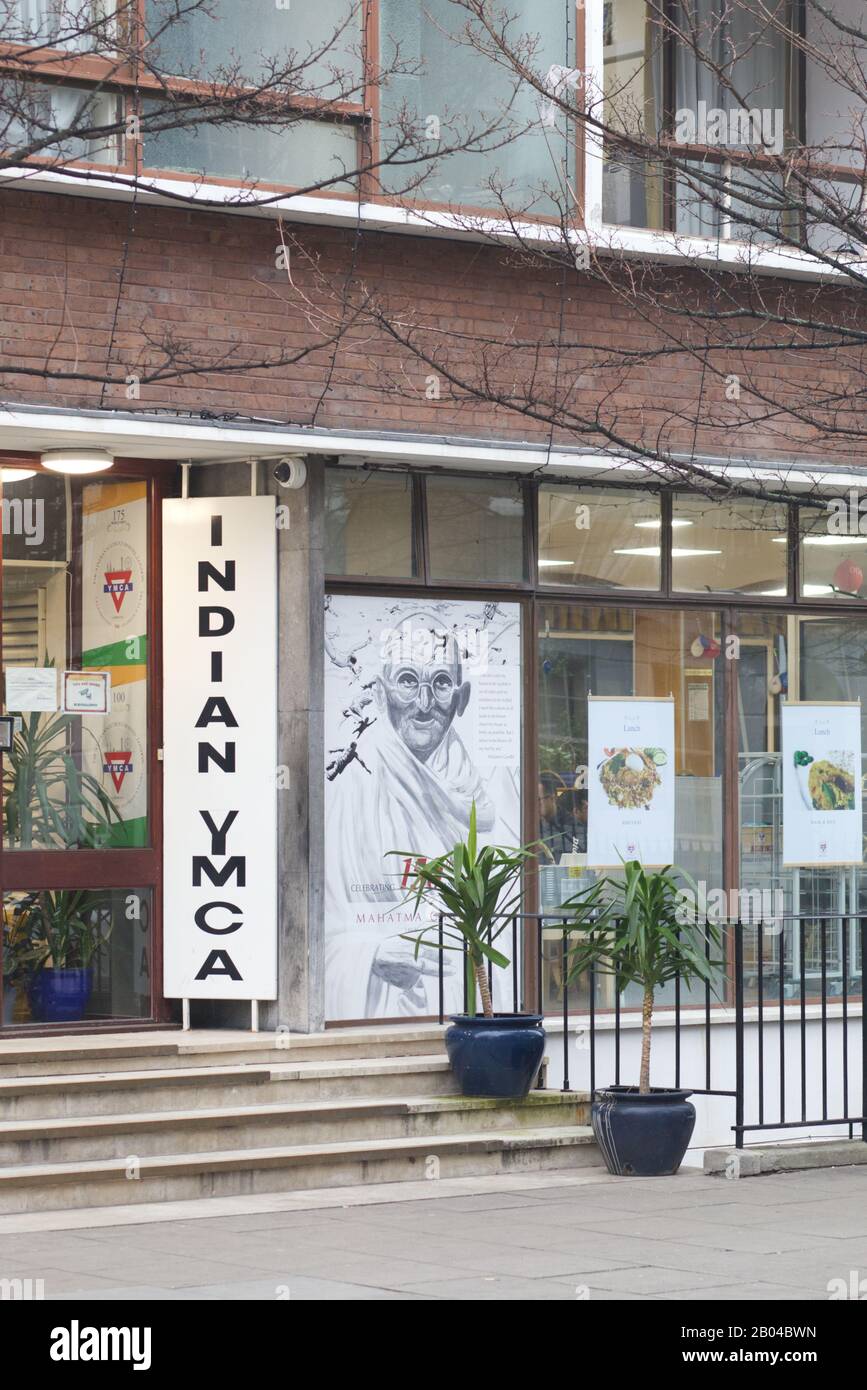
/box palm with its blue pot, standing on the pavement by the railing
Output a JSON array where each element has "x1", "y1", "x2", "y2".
[{"x1": 564, "y1": 860, "x2": 721, "y2": 1177}]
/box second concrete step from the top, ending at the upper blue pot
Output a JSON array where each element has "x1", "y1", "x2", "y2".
[{"x1": 0, "y1": 1052, "x2": 454, "y2": 1123}]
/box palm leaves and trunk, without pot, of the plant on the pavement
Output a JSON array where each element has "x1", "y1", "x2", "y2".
[{"x1": 563, "y1": 859, "x2": 723, "y2": 1095}]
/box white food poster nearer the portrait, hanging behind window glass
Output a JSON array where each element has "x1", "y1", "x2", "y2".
[{"x1": 588, "y1": 696, "x2": 674, "y2": 869}]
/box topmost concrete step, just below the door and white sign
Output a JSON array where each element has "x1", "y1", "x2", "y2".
[{"x1": 0, "y1": 1023, "x2": 447, "y2": 1077}]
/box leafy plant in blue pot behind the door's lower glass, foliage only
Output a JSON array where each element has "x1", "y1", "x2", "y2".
[{"x1": 17, "y1": 888, "x2": 111, "y2": 976}]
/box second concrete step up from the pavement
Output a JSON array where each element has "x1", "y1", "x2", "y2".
[{"x1": 0, "y1": 1091, "x2": 589, "y2": 1165}]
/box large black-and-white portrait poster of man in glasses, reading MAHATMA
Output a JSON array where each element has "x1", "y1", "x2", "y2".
[{"x1": 325, "y1": 595, "x2": 521, "y2": 1019}]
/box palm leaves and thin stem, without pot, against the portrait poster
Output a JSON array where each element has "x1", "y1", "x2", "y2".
[{"x1": 389, "y1": 802, "x2": 538, "y2": 1017}]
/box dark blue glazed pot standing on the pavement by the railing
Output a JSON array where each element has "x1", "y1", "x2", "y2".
[{"x1": 591, "y1": 1086, "x2": 695, "y2": 1177}]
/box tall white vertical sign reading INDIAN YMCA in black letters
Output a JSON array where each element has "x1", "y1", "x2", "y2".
[{"x1": 163, "y1": 496, "x2": 276, "y2": 999}]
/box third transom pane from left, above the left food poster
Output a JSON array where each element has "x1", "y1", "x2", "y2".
[{"x1": 539, "y1": 485, "x2": 661, "y2": 589}]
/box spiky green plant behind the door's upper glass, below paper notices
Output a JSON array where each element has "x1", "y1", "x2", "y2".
[{"x1": 3, "y1": 712, "x2": 122, "y2": 849}]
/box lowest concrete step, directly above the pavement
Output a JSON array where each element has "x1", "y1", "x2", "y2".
[{"x1": 0, "y1": 1125, "x2": 600, "y2": 1213}]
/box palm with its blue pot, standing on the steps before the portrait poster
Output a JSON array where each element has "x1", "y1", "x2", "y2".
[{"x1": 392, "y1": 802, "x2": 586, "y2": 1098}]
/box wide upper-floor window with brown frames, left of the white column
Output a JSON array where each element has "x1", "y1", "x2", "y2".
[{"x1": 0, "y1": 0, "x2": 581, "y2": 217}]
